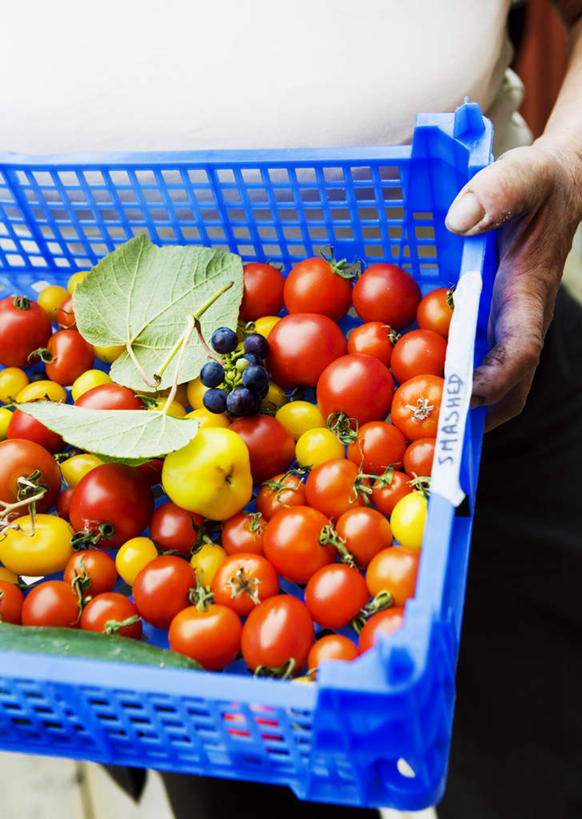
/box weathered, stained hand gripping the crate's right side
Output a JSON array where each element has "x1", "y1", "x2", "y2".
[{"x1": 445, "y1": 143, "x2": 582, "y2": 430}]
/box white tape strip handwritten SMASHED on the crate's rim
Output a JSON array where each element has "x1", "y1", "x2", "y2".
[{"x1": 431, "y1": 270, "x2": 483, "y2": 506}]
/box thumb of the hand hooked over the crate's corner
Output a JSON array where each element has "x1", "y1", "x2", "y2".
[{"x1": 445, "y1": 146, "x2": 552, "y2": 236}]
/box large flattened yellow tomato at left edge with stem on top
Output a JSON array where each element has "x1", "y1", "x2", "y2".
[{"x1": 0, "y1": 515, "x2": 74, "y2": 577}]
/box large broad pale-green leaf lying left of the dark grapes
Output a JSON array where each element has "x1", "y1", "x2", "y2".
[{"x1": 73, "y1": 236, "x2": 243, "y2": 391}]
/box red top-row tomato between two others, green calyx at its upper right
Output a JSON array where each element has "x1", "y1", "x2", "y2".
[{"x1": 283, "y1": 256, "x2": 352, "y2": 321}]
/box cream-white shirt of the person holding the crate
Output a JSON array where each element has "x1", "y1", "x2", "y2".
[{"x1": 0, "y1": 0, "x2": 511, "y2": 153}]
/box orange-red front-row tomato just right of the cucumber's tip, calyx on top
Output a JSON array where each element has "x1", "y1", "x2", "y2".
[{"x1": 168, "y1": 603, "x2": 242, "y2": 671}]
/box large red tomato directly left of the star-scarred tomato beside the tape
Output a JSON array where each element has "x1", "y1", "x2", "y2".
[{"x1": 317, "y1": 354, "x2": 394, "y2": 424}]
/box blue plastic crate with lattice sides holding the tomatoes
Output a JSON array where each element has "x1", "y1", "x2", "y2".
[{"x1": 0, "y1": 103, "x2": 495, "y2": 809}]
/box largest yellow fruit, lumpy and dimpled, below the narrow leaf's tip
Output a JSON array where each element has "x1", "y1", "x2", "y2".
[{"x1": 162, "y1": 427, "x2": 253, "y2": 520}]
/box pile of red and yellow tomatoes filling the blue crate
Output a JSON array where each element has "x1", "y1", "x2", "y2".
[{"x1": 0, "y1": 257, "x2": 452, "y2": 679}]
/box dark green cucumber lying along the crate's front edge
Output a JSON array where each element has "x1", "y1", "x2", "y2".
[{"x1": 0, "y1": 623, "x2": 202, "y2": 670}]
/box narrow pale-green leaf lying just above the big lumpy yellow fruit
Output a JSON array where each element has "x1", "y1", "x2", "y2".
[{"x1": 16, "y1": 401, "x2": 198, "y2": 464}]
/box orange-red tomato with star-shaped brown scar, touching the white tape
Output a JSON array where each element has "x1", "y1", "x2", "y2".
[{"x1": 391, "y1": 375, "x2": 445, "y2": 441}]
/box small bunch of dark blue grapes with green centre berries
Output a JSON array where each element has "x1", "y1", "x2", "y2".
[{"x1": 200, "y1": 327, "x2": 269, "y2": 417}]
